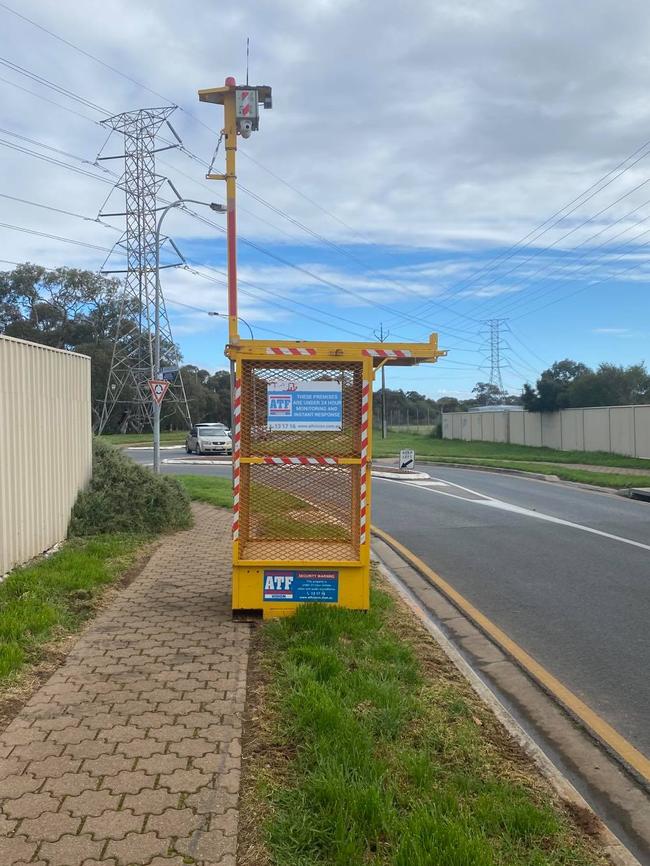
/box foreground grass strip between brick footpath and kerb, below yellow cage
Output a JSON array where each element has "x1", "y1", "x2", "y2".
[{"x1": 249, "y1": 591, "x2": 604, "y2": 866}]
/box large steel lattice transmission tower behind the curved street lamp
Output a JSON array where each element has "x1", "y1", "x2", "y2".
[{"x1": 98, "y1": 106, "x2": 191, "y2": 433}]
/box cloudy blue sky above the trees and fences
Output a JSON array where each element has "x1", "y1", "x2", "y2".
[{"x1": 0, "y1": 0, "x2": 650, "y2": 399}]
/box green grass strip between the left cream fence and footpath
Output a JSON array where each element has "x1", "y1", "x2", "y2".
[{"x1": 0, "y1": 534, "x2": 146, "y2": 684}]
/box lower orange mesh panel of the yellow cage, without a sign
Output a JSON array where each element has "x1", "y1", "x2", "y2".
[{"x1": 239, "y1": 464, "x2": 359, "y2": 560}]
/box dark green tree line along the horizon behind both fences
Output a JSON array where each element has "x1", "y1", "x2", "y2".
[{"x1": 0, "y1": 263, "x2": 650, "y2": 432}]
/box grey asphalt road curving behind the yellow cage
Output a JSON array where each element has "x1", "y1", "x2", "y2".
[{"x1": 128, "y1": 449, "x2": 650, "y2": 755}]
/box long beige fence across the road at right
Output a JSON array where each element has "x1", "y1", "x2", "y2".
[{"x1": 442, "y1": 404, "x2": 650, "y2": 458}]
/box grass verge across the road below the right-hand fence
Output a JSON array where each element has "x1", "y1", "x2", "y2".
[{"x1": 373, "y1": 430, "x2": 650, "y2": 475}]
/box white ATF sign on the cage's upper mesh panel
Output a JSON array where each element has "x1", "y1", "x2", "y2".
[{"x1": 267, "y1": 381, "x2": 343, "y2": 430}]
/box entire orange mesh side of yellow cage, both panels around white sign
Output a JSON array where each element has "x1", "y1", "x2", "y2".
[{"x1": 239, "y1": 359, "x2": 363, "y2": 561}]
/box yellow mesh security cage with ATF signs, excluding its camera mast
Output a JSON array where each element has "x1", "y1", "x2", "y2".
[{"x1": 226, "y1": 335, "x2": 446, "y2": 618}]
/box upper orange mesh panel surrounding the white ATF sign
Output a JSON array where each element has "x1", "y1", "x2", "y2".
[{"x1": 242, "y1": 359, "x2": 363, "y2": 457}]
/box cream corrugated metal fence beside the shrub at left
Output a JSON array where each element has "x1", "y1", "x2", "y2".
[{"x1": 0, "y1": 336, "x2": 92, "y2": 575}]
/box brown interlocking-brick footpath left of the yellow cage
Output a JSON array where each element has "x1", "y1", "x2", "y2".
[{"x1": 0, "y1": 505, "x2": 250, "y2": 866}]
